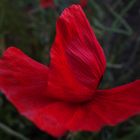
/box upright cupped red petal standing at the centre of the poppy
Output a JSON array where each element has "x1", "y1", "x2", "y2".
[{"x1": 48, "y1": 5, "x2": 106, "y2": 102}]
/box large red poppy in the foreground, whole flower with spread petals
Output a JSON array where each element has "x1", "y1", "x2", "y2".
[{"x1": 0, "y1": 5, "x2": 140, "y2": 137}]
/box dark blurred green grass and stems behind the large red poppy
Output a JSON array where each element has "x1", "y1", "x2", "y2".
[{"x1": 0, "y1": 0, "x2": 140, "y2": 140}]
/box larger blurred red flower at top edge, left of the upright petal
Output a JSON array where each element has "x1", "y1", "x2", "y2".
[{"x1": 40, "y1": 0, "x2": 54, "y2": 8}]
